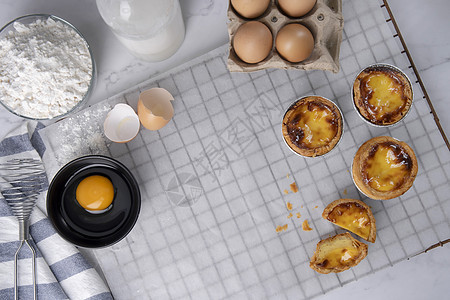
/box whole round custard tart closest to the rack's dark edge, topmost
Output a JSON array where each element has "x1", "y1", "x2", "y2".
[{"x1": 353, "y1": 64, "x2": 413, "y2": 126}]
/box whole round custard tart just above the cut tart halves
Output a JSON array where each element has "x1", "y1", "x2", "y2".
[{"x1": 352, "y1": 136, "x2": 418, "y2": 200}]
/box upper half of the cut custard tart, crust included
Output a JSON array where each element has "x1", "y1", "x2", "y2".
[{"x1": 322, "y1": 199, "x2": 377, "y2": 243}]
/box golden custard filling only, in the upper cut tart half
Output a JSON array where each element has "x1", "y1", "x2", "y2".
[{"x1": 327, "y1": 203, "x2": 370, "y2": 240}]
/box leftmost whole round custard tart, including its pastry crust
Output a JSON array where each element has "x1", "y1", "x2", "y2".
[{"x1": 282, "y1": 96, "x2": 343, "y2": 157}]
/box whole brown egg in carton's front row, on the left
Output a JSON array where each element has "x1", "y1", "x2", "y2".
[{"x1": 233, "y1": 21, "x2": 273, "y2": 64}]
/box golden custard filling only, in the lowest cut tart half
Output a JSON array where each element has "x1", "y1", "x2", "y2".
[{"x1": 317, "y1": 239, "x2": 360, "y2": 269}]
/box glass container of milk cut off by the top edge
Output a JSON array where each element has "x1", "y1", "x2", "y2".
[{"x1": 96, "y1": 0, "x2": 185, "y2": 62}]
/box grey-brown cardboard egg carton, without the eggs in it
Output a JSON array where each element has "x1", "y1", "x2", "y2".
[{"x1": 227, "y1": 0, "x2": 344, "y2": 73}]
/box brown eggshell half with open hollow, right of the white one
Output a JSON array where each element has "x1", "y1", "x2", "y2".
[{"x1": 138, "y1": 88, "x2": 174, "y2": 130}]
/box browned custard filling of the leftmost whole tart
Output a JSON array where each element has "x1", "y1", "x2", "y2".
[{"x1": 287, "y1": 102, "x2": 338, "y2": 149}]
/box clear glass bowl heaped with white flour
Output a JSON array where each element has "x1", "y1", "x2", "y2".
[{"x1": 0, "y1": 14, "x2": 95, "y2": 120}]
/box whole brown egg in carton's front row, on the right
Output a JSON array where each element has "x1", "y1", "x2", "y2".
[{"x1": 275, "y1": 23, "x2": 314, "y2": 63}]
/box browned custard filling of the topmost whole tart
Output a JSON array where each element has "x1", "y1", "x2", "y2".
[{"x1": 360, "y1": 69, "x2": 409, "y2": 122}]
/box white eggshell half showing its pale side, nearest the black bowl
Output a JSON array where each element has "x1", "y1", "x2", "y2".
[{"x1": 103, "y1": 103, "x2": 141, "y2": 143}]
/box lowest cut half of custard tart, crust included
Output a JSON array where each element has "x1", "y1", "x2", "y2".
[{"x1": 309, "y1": 232, "x2": 368, "y2": 274}]
